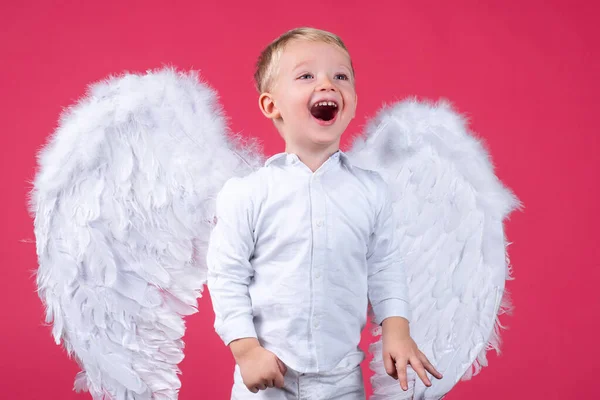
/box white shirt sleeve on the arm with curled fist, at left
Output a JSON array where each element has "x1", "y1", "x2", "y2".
[{"x1": 206, "y1": 177, "x2": 257, "y2": 345}]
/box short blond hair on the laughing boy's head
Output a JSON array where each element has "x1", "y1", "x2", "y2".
[{"x1": 254, "y1": 27, "x2": 354, "y2": 93}]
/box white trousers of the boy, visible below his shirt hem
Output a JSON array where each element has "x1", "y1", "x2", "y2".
[{"x1": 231, "y1": 365, "x2": 366, "y2": 400}]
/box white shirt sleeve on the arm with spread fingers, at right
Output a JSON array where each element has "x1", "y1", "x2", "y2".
[{"x1": 367, "y1": 175, "x2": 411, "y2": 325}]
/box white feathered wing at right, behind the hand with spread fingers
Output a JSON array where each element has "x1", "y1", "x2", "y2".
[{"x1": 349, "y1": 101, "x2": 519, "y2": 400}]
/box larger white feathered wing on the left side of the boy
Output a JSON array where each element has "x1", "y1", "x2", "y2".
[{"x1": 30, "y1": 69, "x2": 263, "y2": 399}]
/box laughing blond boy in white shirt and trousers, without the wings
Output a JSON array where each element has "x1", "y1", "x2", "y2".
[{"x1": 207, "y1": 28, "x2": 441, "y2": 400}]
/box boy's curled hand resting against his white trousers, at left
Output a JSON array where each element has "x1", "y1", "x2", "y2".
[{"x1": 236, "y1": 346, "x2": 287, "y2": 393}]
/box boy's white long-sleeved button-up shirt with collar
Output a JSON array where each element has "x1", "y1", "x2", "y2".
[{"x1": 207, "y1": 151, "x2": 410, "y2": 373}]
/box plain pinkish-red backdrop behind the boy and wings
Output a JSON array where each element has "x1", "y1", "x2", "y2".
[{"x1": 0, "y1": 0, "x2": 600, "y2": 400}]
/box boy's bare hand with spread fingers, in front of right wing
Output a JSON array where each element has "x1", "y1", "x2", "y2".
[{"x1": 383, "y1": 318, "x2": 442, "y2": 391}]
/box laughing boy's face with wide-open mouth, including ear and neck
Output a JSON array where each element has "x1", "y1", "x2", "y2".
[{"x1": 260, "y1": 40, "x2": 357, "y2": 150}]
